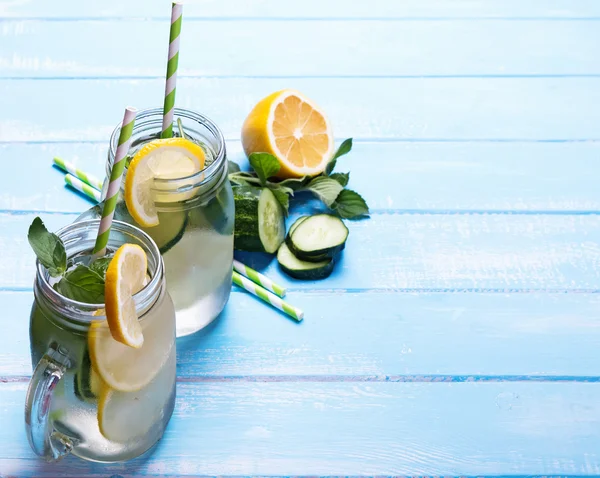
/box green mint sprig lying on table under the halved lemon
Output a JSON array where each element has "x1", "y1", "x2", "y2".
[{"x1": 229, "y1": 138, "x2": 369, "y2": 219}]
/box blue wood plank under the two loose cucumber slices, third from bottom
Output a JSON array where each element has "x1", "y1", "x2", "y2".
[{"x1": 0, "y1": 209, "x2": 600, "y2": 291}]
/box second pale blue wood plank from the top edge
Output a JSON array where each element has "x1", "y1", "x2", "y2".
[{"x1": 0, "y1": 18, "x2": 600, "y2": 79}]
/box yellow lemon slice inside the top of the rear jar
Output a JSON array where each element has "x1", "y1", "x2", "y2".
[{"x1": 125, "y1": 138, "x2": 205, "y2": 227}]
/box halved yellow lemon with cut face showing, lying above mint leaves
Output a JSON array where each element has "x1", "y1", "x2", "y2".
[{"x1": 242, "y1": 90, "x2": 334, "y2": 179}]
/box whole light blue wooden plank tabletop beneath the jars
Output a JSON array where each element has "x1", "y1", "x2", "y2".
[{"x1": 0, "y1": 0, "x2": 600, "y2": 477}]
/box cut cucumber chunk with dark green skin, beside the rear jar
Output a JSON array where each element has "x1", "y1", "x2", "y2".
[{"x1": 234, "y1": 187, "x2": 285, "y2": 254}]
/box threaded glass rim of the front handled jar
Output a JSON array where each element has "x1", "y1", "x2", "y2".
[{"x1": 36, "y1": 219, "x2": 164, "y2": 324}]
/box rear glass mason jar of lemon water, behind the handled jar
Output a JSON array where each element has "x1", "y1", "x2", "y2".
[{"x1": 80, "y1": 108, "x2": 235, "y2": 337}]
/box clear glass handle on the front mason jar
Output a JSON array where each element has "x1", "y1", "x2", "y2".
[{"x1": 25, "y1": 348, "x2": 73, "y2": 461}]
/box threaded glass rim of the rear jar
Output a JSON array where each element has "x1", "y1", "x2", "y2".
[{"x1": 106, "y1": 108, "x2": 227, "y2": 193}]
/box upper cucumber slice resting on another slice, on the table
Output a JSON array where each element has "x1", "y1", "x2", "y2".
[{"x1": 286, "y1": 214, "x2": 348, "y2": 262}]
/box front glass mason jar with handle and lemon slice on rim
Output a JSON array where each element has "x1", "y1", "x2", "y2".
[{"x1": 25, "y1": 220, "x2": 176, "y2": 462}]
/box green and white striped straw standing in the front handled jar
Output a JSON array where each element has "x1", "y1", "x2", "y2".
[{"x1": 94, "y1": 106, "x2": 136, "y2": 258}]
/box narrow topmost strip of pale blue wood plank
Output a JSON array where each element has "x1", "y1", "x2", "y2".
[{"x1": 0, "y1": 0, "x2": 600, "y2": 21}]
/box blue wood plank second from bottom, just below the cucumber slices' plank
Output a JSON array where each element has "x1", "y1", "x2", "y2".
[{"x1": 0, "y1": 292, "x2": 600, "y2": 381}]
